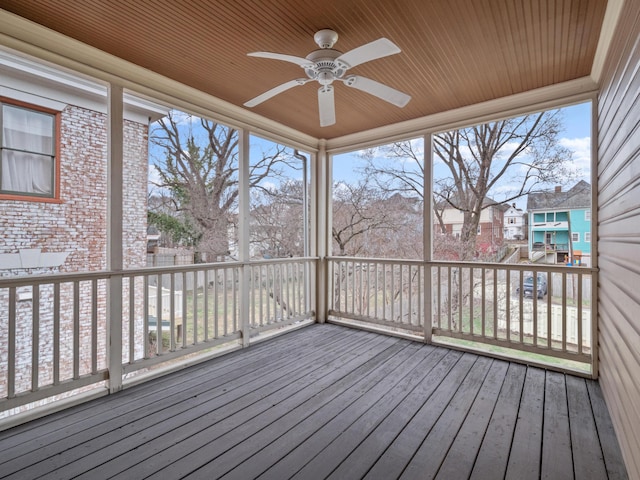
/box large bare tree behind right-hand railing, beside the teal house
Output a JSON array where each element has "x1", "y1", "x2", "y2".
[{"x1": 365, "y1": 110, "x2": 572, "y2": 260}]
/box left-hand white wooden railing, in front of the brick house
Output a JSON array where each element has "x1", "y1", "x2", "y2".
[{"x1": 0, "y1": 258, "x2": 316, "y2": 415}]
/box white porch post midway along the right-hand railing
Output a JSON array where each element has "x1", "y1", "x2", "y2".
[{"x1": 422, "y1": 133, "x2": 432, "y2": 343}]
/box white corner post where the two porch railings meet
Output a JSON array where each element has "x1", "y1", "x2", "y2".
[{"x1": 311, "y1": 140, "x2": 331, "y2": 323}]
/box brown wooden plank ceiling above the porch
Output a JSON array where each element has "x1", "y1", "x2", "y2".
[{"x1": 0, "y1": 0, "x2": 606, "y2": 139}]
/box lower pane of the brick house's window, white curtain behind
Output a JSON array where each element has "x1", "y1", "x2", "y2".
[{"x1": 1, "y1": 150, "x2": 53, "y2": 195}]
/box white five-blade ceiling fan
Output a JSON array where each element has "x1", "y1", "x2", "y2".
[{"x1": 244, "y1": 29, "x2": 411, "y2": 127}]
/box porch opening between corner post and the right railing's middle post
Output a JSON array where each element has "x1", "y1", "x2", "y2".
[{"x1": 331, "y1": 138, "x2": 424, "y2": 259}]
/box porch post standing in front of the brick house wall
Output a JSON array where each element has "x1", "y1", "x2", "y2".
[{"x1": 107, "y1": 84, "x2": 123, "y2": 393}]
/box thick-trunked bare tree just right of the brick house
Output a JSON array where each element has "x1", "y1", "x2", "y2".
[{"x1": 151, "y1": 111, "x2": 296, "y2": 261}]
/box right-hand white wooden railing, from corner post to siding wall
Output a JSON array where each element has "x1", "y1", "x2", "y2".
[{"x1": 328, "y1": 257, "x2": 596, "y2": 374}]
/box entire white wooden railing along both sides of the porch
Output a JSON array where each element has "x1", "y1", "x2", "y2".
[{"x1": 0, "y1": 253, "x2": 597, "y2": 416}]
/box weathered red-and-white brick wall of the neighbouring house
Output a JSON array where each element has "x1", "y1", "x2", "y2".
[{"x1": 0, "y1": 106, "x2": 148, "y2": 394}]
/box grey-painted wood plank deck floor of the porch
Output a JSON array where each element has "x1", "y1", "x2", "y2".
[{"x1": 0, "y1": 324, "x2": 626, "y2": 480}]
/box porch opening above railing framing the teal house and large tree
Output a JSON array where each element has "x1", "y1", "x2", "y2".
[{"x1": 433, "y1": 103, "x2": 591, "y2": 263}]
